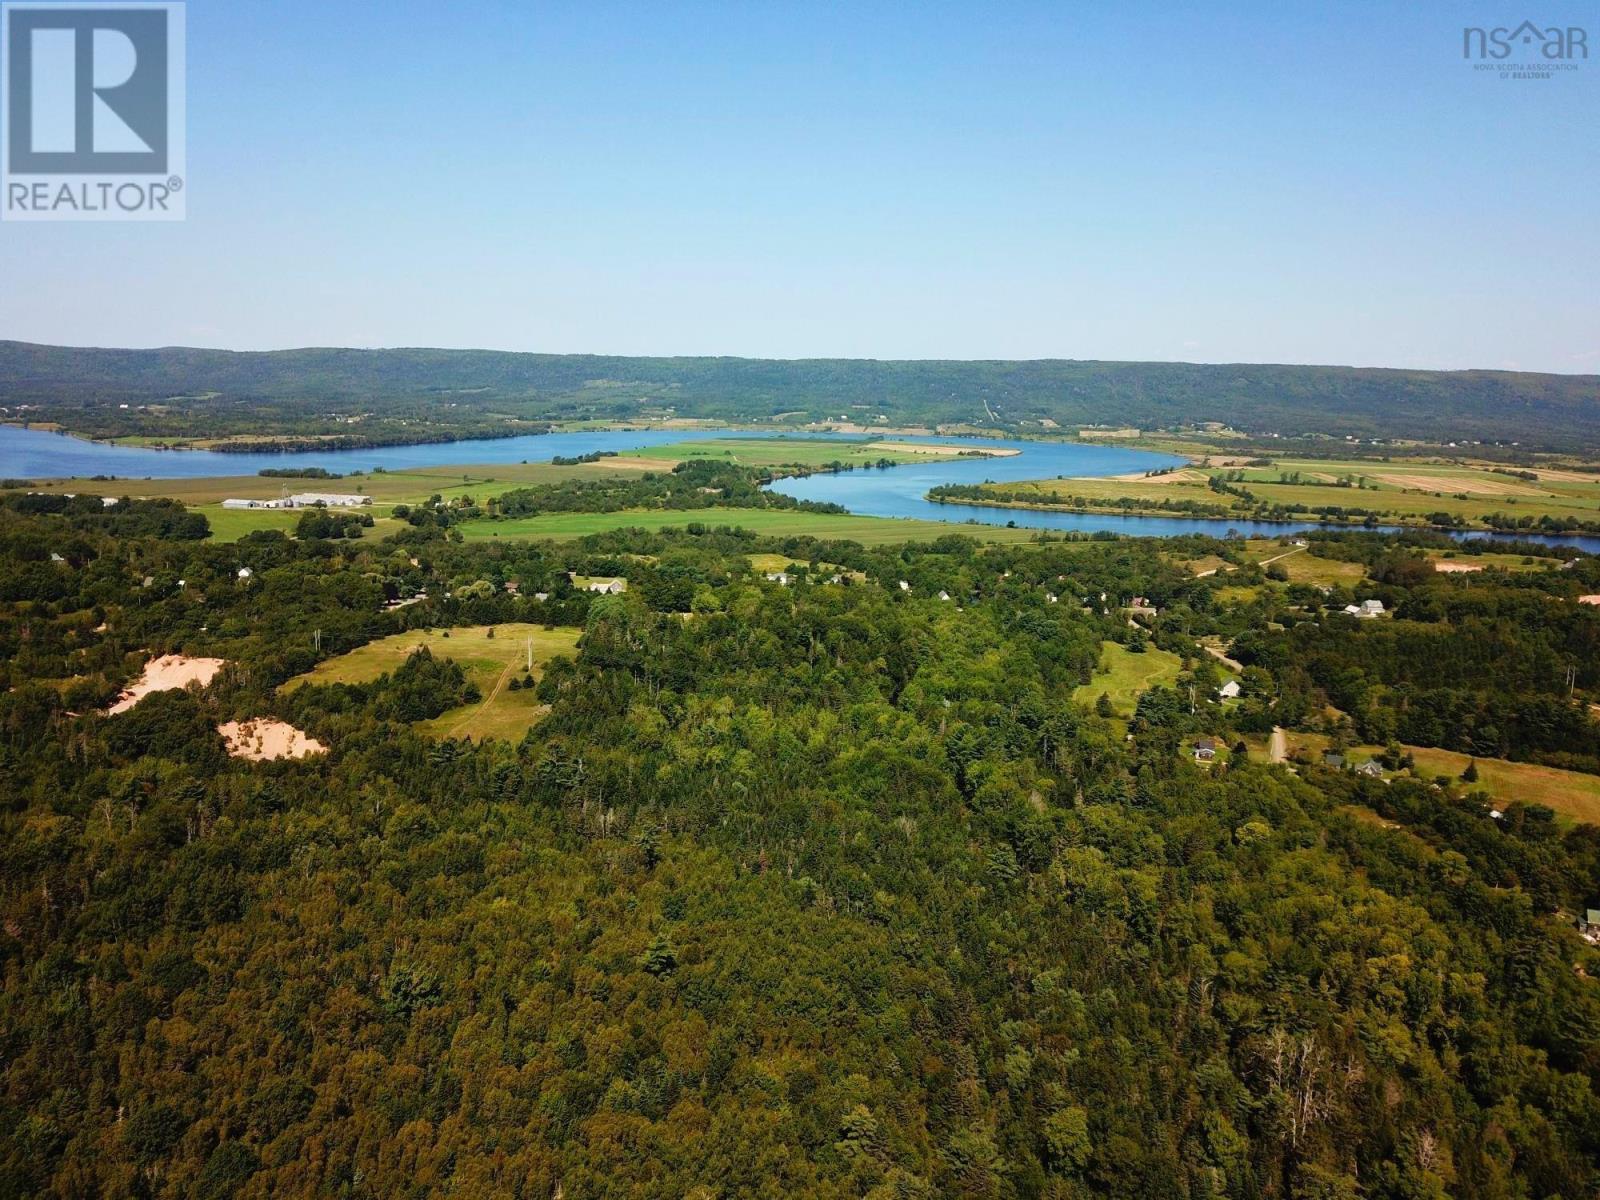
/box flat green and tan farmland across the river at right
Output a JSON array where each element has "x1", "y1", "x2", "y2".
[{"x1": 979, "y1": 459, "x2": 1600, "y2": 534}]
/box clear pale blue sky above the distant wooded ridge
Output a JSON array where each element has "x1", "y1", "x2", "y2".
[{"x1": 0, "y1": 0, "x2": 1600, "y2": 373}]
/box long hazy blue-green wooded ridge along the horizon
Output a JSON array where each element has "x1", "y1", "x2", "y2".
[{"x1": 9, "y1": 341, "x2": 1600, "y2": 448}]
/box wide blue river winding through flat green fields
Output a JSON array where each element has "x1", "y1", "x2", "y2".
[{"x1": 0, "y1": 426, "x2": 1600, "y2": 554}]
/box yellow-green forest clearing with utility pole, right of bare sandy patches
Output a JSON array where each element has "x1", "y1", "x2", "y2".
[{"x1": 283, "y1": 622, "x2": 582, "y2": 741}]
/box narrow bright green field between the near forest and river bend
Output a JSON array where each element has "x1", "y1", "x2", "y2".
[{"x1": 456, "y1": 509, "x2": 1037, "y2": 546}]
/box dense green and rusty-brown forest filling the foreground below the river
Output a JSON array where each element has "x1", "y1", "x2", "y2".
[{"x1": 0, "y1": 496, "x2": 1600, "y2": 1200}]
